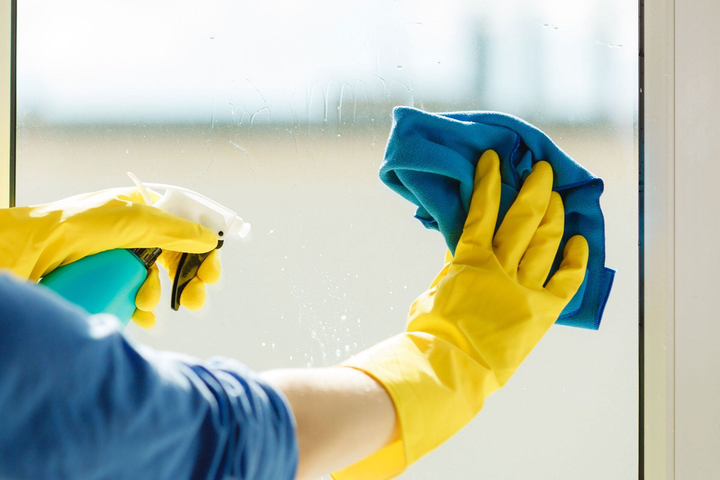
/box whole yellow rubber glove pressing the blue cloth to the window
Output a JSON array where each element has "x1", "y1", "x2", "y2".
[{"x1": 333, "y1": 151, "x2": 588, "y2": 480}]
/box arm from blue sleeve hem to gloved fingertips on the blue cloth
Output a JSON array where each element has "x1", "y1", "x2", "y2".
[{"x1": 266, "y1": 151, "x2": 588, "y2": 480}]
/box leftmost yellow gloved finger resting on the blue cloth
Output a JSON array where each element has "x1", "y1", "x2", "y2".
[{"x1": 455, "y1": 150, "x2": 500, "y2": 257}]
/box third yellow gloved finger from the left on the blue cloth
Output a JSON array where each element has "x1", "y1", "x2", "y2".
[{"x1": 518, "y1": 192, "x2": 565, "y2": 288}]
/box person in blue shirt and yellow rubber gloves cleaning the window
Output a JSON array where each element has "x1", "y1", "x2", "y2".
[{"x1": 0, "y1": 150, "x2": 588, "y2": 480}]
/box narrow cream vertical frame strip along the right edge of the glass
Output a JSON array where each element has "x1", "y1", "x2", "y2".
[{"x1": 639, "y1": 0, "x2": 675, "y2": 480}]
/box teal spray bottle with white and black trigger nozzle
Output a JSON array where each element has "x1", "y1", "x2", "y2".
[{"x1": 40, "y1": 173, "x2": 250, "y2": 325}]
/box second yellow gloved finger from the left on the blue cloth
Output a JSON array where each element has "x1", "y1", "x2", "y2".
[{"x1": 493, "y1": 162, "x2": 553, "y2": 276}]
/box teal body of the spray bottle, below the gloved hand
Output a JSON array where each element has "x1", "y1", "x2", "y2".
[{"x1": 40, "y1": 249, "x2": 157, "y2": 325}]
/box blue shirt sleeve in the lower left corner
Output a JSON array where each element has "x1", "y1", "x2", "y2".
[{"x1": 0, "y1": 275, "x2": 298, "y2": 480}]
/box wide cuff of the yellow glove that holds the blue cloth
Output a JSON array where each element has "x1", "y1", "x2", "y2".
[{"x1": 332, "y1": 332, "x2": 501, "y2": 480}]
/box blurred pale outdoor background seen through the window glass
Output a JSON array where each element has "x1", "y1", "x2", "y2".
[{"x1": 17, "y1": 0, "x2": 638, "y2": 480}]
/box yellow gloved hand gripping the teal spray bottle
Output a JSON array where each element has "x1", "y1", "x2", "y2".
[{"x1": 0, "y1": 188, "x2": 220, "y2": 328}]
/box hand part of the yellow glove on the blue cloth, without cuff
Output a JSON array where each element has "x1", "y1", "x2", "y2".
[{"x1": 408, "y1": 150, "x2": 588, "y2": 385}]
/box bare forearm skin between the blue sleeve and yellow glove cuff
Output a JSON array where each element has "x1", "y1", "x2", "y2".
[{"x1": 261, "y1": 368, "x2": 397, "y2": 480}]
